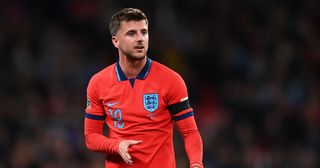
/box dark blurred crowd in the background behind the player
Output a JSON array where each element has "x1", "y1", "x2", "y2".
[{"x1": 0, "y1": 0, "x2": 320, "y2": 168}]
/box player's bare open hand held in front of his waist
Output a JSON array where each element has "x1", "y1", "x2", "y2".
[{"x1": 118, "y1": 140, "x2": 142, "y2": 165}]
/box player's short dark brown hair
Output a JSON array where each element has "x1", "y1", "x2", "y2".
[{"x1": 109, "y1": 8, "x2": 148, "y2": 36}]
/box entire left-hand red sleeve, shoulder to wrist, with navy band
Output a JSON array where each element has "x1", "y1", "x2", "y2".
[{"x1": 84, "y1": 78, "x2": 120, "y2": 153}]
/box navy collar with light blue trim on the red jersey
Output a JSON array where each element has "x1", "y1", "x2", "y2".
[{"x1": 116, "y1": 58, "x2": 152, "y2": 81}]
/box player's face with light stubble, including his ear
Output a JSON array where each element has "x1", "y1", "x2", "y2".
[{"x1": 112, "y1": 20, "x2": 149, "y2": 60}]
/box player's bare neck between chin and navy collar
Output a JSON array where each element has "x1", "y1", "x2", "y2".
[{"x1": 119, "y1": 56, "x2": 147, "y2": 79}]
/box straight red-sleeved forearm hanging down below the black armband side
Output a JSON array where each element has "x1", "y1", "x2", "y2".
[{"x1": 176, "y1": 117, "x2": 203, "y2": 167}]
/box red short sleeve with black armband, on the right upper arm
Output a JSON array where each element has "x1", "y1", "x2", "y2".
[{"x1": 168, "y1": 73, "x2": 193, "y2": 121}]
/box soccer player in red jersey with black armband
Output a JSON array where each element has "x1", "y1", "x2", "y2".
[{"x1": 84, "y1": 8, "x2": 203, "y2": 168}]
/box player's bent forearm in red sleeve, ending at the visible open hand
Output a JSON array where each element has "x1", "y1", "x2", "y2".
[{"x1": 84, "y1": 118, "x2": 120, "y2": 153}]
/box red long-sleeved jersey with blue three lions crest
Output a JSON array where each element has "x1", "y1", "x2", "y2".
[{"x1": 85, "y1": 58, "x2": 202, "y2": 168}]
